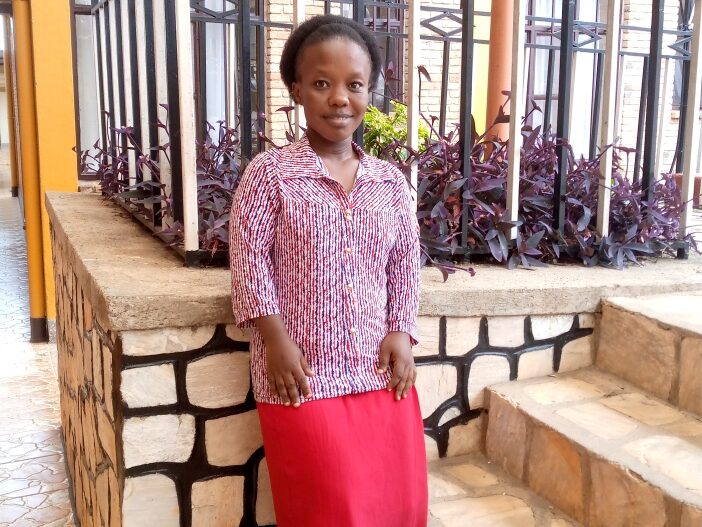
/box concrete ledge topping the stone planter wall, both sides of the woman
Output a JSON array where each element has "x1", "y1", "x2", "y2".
[{"x1": 46, "y1": 193, "x2": 702, "y2": 331}]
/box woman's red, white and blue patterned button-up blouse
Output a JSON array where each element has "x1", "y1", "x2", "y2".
[{"x1": 230, "y1": 137, "x2": 419, "y2": 403}]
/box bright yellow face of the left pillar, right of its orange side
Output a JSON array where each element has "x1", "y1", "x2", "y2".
[{"x1": 30, "y1": 0, "x2": 78, "y2": 320}]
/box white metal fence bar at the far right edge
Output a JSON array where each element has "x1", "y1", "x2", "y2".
[{"x1": 679, "y1": 3, "x2": 702, "y2": 242}]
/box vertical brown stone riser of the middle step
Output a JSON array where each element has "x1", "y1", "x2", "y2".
[{"x1": 484, "y1": 381, "x2": 702, "y2": 527}]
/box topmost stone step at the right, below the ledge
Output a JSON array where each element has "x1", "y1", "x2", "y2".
[{"x1": 595, "y1": 294, "x2": 702, "y2": 415}]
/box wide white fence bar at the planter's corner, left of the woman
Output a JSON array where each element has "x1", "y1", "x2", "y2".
[{"x1": 174, "y1": 0, "x2": 200, "y2": 256}]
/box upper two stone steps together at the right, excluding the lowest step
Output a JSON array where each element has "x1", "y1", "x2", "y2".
[{"x1": 485, "y1": 294, "x2": 702, "y2": 527}]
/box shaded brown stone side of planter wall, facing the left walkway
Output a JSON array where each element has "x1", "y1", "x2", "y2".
[{"x1": 51, "y1": 229, "x2": 122, "y2": 527}]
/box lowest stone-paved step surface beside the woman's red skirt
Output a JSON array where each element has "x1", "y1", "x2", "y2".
[{"x1": 429, "y1": 453, "x2": 581, "y2": 527}]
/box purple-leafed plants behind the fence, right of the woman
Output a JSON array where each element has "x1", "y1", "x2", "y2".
[{"x1": 374, "y1": 98, "x2": 696, "y2": 273}]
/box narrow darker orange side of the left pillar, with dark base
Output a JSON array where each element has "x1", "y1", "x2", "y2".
[{"x1": 12, "y1": 0, "x2": 48, "y2": 342}]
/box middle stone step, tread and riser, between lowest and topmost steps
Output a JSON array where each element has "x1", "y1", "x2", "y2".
[{"x1": 485, "y1": 367, "x2": 702, "y2": 527}]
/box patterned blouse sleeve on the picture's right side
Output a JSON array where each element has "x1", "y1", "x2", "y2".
[{"x1": 386, "y1": 170, "x2": 420, "y2": 344}]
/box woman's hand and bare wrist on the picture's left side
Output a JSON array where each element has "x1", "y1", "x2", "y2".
[{"x1": 254, "y1": 315, "x2": 314, "y2": 408}]
